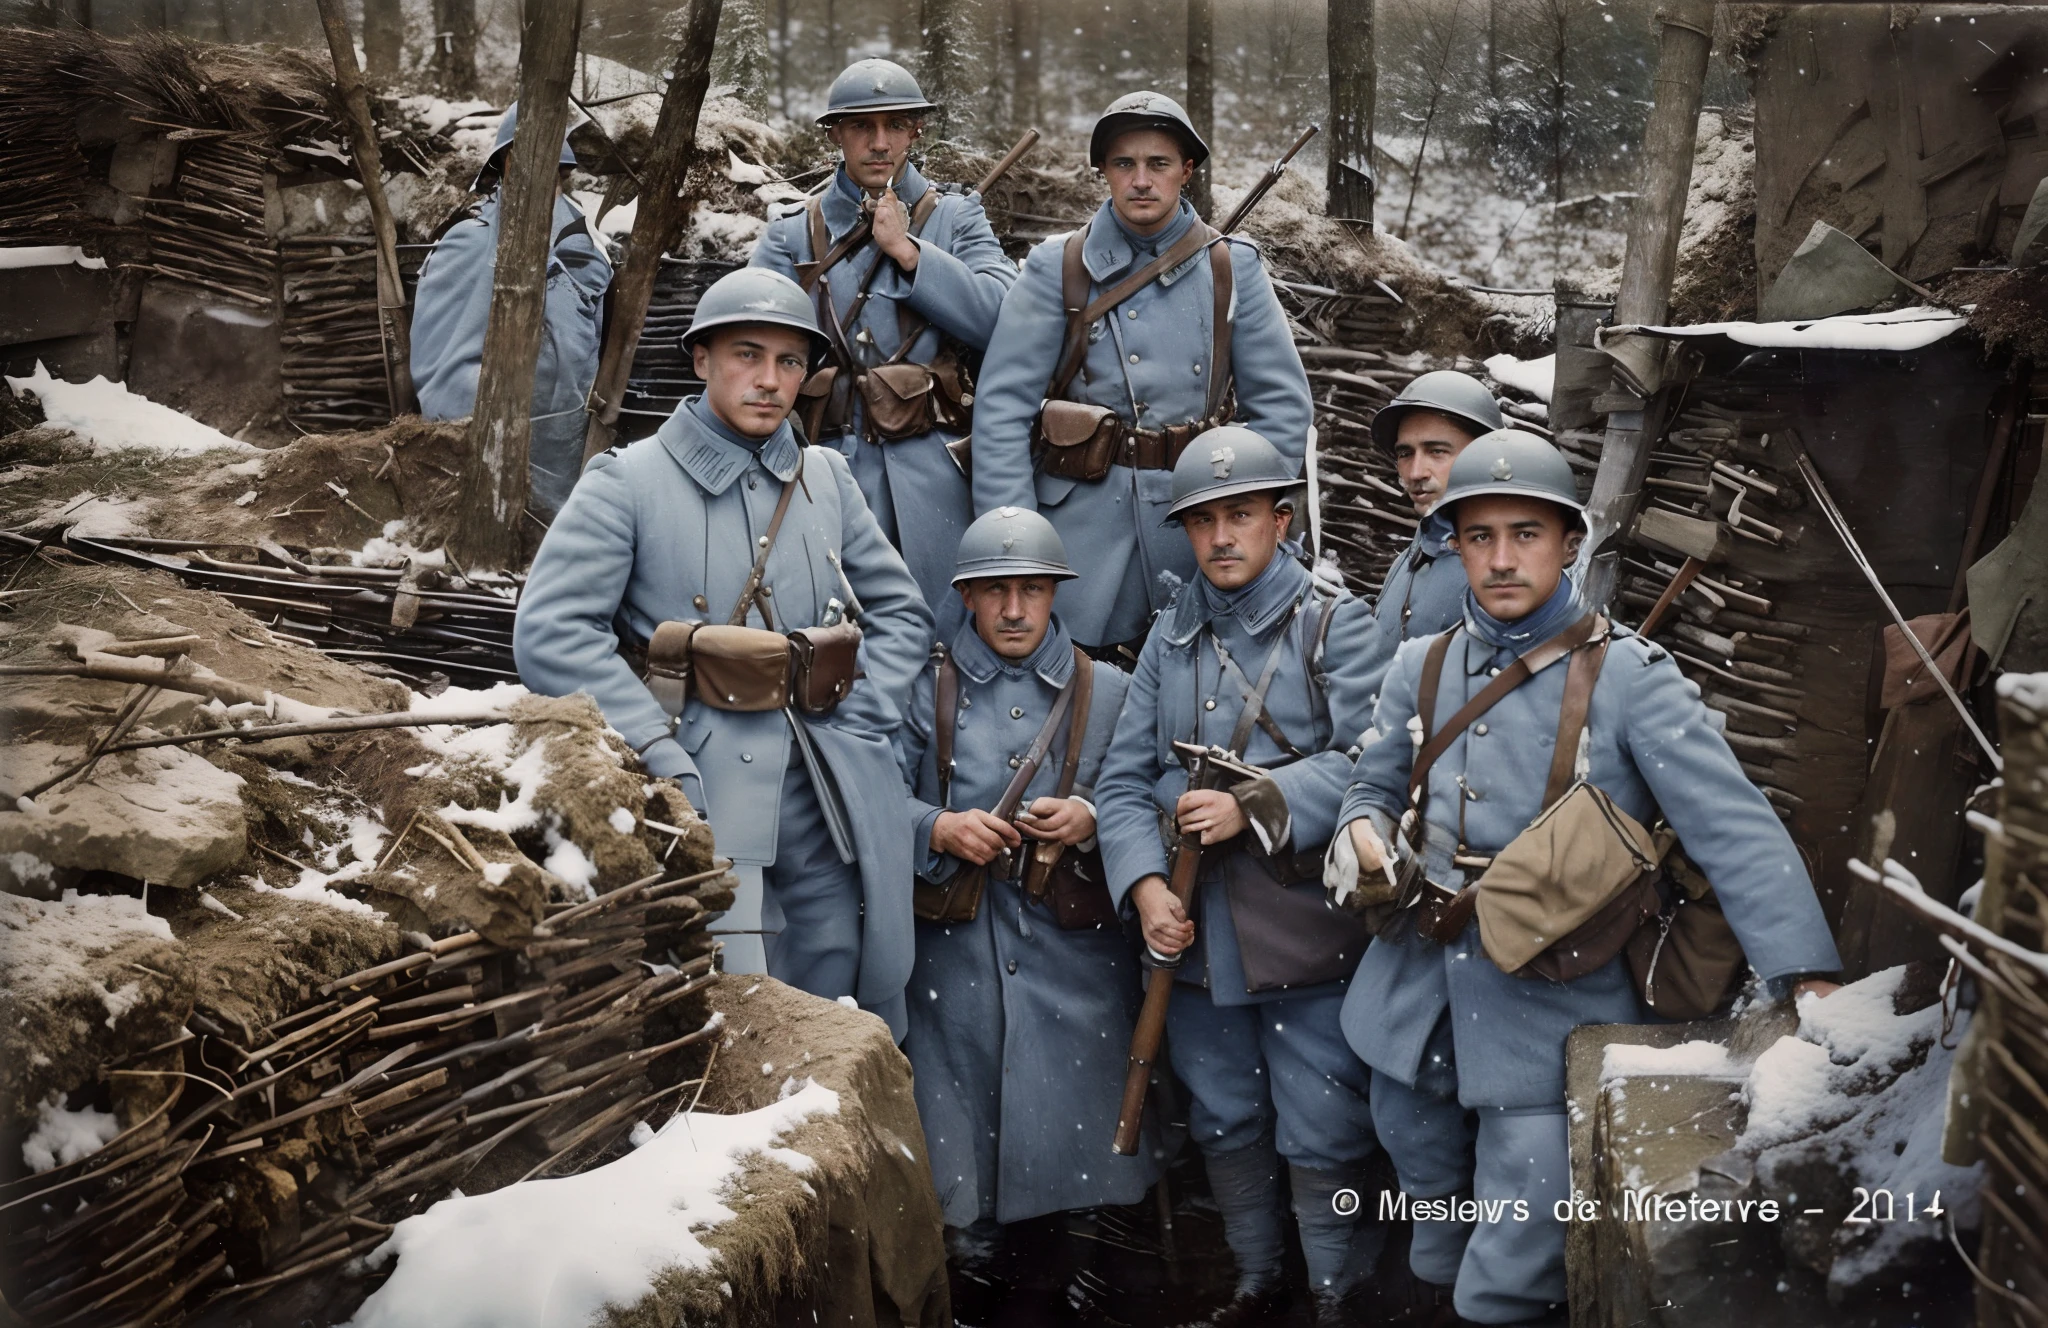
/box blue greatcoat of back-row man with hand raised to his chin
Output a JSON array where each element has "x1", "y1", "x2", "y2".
[{"x1": 750, "y1": 166, "x2": 1018, "y2": 623}]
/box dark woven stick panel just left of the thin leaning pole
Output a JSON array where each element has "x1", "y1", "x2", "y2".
[{"x1": 283, "y1": 236, "x2": 391, "y2": 432}]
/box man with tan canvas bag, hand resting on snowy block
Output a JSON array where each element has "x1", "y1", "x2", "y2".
[{"x1": 1329, "y1": 428, "x2": 1839, "y2": 1324}]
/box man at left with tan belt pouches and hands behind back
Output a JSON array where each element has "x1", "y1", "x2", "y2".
[{"x1": 512, "y1": 268, "x2": 932, "y2": 1037}]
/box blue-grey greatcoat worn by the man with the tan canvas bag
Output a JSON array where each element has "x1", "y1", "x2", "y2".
[{"x1": 1339, "y1": 602, "x2": 1841, "y2": 1109}]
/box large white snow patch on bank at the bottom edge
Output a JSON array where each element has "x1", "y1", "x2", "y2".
[{"x1": 350, "y1": 1080, "x2": 840, "y2": 1328}]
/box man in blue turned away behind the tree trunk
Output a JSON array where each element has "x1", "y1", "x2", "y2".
[{"x1": 412, "y1": 102, "x2": 612, "y2": 523}]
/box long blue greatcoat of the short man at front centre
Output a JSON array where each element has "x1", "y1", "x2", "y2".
[{"x1": 899, "y1": 619, "x2": 1159, "y2": 1228}]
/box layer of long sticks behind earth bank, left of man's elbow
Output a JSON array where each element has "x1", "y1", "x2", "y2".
[{"x1": 52, "y1": 532, "x2": 522, "y2": 687}]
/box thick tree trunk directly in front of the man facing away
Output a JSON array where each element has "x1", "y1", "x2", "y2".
[{"x1": 448, "y1": 0, "x2": 584, "y2": 570}]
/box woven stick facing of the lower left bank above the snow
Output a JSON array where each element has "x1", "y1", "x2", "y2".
[{"x1": 0, "y1": 863, "x2": 725, "y2": 1328}]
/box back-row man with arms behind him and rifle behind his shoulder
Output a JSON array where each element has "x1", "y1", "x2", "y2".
[{"x1": 973, "y1": 92, "x2": 1311, "y2": 650}]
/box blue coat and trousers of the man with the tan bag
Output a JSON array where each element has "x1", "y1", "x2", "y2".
[{"x1": 1337, "y1": 434, "x2": 1839, "y2": 1324}]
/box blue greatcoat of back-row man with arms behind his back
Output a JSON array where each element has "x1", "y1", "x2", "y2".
[{"x1": 973, "y1": 201, "x2": 1310, "y2": 647}]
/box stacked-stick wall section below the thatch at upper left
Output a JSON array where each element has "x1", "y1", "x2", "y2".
[{"x1": 129, "y1": 129, "x2": 279, "y2": 309}]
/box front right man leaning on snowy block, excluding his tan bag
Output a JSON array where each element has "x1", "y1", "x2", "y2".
[{"x1": 1329, "y1": 428, "x2": 1839, "y2": 1324}]
